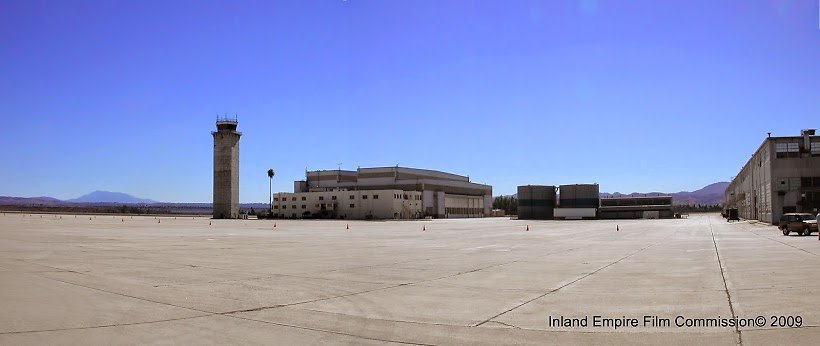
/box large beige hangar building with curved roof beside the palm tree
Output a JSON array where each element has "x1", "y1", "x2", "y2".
[{"x1": 272, "y1": 167, "x2": 493, "y2": 219}]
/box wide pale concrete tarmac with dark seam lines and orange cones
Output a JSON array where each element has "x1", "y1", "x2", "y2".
[{"x1": 0, "y1": 213, "x2": 820, "y2": 345}]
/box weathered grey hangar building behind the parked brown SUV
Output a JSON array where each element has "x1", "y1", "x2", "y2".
[{"x1": 724, "y1": 129, "x2": 820, "y2": 224}]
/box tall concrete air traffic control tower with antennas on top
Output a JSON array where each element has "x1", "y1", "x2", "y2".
[{"x1": 211, "y1": 117, "x2": 242, "y2": 219}]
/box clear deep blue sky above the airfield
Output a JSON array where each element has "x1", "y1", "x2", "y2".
[{"x1": 0, "y1": 0, "x2": 820, "y2": 203}]
